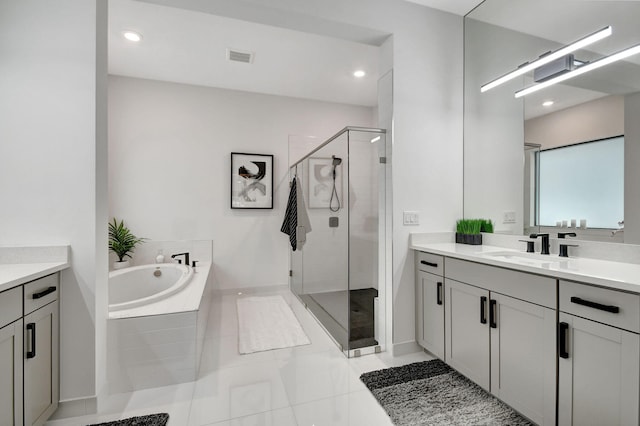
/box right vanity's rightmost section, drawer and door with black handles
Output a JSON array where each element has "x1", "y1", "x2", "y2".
[{"x1": 558, "y1": 281, "x2": 640, "y2": 425}]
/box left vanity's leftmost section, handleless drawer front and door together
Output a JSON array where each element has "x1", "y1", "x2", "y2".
[{"x1": 0, "y1": 287, "x2": 22, "y2": 426}]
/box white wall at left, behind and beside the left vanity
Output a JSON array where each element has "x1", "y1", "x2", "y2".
[{"x1": 0, "y1": 0, "x2": 106, "y2": 406}]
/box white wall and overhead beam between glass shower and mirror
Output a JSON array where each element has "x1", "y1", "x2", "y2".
[{"x1": 135, "y1": 0, "x2": 463, "y2": 350}]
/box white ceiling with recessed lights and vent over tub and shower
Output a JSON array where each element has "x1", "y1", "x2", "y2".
[{"x1": 109, "y1": 0, "x2": 479, "y2": 107}]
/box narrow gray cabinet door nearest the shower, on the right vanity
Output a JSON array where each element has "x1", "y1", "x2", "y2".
[{"x1": 417, "y1": 271, "x2": 444, "y2": 360}]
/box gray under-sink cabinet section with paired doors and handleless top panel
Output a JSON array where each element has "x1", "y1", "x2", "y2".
[{"x1": 445, "y1": 257, "x2": 556, "y2": 425}]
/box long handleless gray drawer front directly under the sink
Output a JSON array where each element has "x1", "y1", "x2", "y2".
[{"x1": 446, "y1": 257, "x2": 556, "y2": 309}]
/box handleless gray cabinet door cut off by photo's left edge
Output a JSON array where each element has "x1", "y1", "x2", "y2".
[{"x1": 0, "y1": 320, "x2": 22, "y2": 426}]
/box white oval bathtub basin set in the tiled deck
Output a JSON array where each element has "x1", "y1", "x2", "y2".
[{"x1": 109, "y1": 263, "x2": 193, "y2": 312}]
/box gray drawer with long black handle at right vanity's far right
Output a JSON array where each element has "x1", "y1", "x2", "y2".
[{"x1": 560, "y1": 280, "x2": 640, "y2": 333}]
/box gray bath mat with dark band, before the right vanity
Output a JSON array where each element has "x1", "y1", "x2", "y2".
[{"x1": 360, "y1": 360, "x2": 533, "y2": 426}]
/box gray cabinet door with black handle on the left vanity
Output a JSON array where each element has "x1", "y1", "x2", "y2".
[{"x1": 24, "y1": 301, "x2": 59, "y2": 426}]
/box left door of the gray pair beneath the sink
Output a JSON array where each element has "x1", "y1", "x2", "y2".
[{"x1": 444, "y1": 279, "x2": 490, "y2": 391}]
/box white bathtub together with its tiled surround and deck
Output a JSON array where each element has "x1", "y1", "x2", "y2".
[{"x1": 107, "y1": 261, "x2": 214, "y2": 393}]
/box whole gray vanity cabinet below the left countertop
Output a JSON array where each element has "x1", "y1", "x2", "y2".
[{"x1": 0, "y1": 273, "x2": 59, "y2": 426}]
